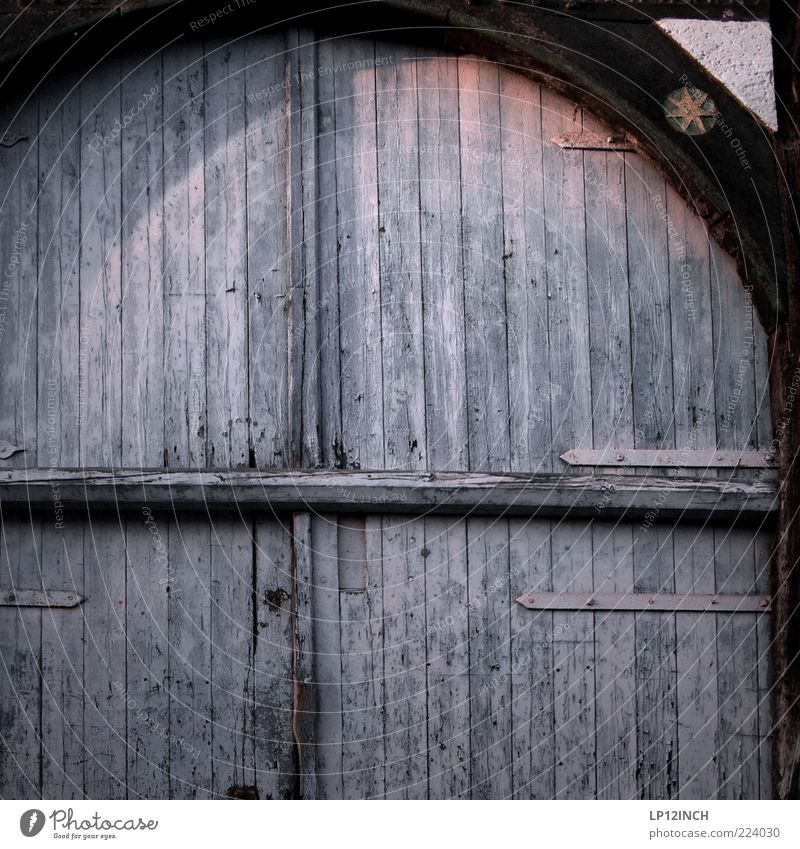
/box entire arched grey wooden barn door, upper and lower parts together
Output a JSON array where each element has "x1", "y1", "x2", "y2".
[{"x1": 0, "y1": 26, "x2": 776, "y2": 799}]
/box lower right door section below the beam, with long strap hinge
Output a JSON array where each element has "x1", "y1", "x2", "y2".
[{"x1": 304, "y1": 515, "x2": 770, "y2": 799}]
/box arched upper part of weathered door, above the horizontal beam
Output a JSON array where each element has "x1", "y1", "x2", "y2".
[{"x1": 0, "y1": 32, "x2": 769, "y2": 472}]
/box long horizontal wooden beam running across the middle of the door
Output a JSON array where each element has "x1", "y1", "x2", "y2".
[{"x1": 0, "y1": 469, "x2": 777, "y2": 521}]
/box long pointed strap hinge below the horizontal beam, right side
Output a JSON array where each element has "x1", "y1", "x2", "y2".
[{"x1": 517, "y1": 592, "x2": 770, "y2": 613}]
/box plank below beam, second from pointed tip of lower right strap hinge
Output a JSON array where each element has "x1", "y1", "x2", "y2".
[{"x1": 551, "y1": 519, "x2": 597, "y2": 799}]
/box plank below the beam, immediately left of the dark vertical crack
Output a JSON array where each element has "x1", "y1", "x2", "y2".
[{"x1": 211, "y1": 516, "x2": 256, "y2": 798}]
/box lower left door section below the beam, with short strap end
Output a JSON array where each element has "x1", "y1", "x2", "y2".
[{"x1": 0, "y1": 508, "x2": 298, "y2": 799}]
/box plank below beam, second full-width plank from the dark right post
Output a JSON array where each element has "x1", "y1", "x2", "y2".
[{"x1": 674, "y1": 526, "x2": 719, "y2": 799}]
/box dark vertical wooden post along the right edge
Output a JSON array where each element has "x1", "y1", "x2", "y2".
[{"x1": 770, "y1": 0, "x2": 800, "y2": 799}]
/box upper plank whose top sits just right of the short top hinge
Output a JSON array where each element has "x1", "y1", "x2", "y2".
[{"x1": 625, "y1": 153, "x2": 675, "y2": 448}]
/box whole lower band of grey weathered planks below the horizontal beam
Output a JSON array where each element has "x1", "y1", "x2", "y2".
[{"x1": 0, "y1": 512, "x2": 770, "y2": 798}]
